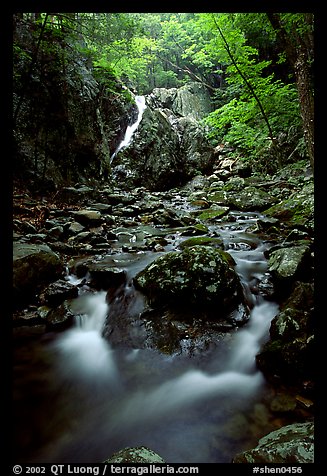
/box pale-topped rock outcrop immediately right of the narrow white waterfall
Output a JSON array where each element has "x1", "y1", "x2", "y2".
[{"x1": 115, "y1": 83, "x2": 215, "y2": 190}]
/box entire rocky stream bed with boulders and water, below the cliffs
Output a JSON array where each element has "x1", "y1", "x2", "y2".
[{"x1": 13, "y1": 154, "x2": 314, "y2": 463}]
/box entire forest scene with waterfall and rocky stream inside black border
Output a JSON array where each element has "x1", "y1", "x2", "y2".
[{"x1": 12, "y1": 10, "x2": 320, "y2": 464}]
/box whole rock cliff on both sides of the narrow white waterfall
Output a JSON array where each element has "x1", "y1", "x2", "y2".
[{"x1": 13, "y1": 18, "x2": 215, "y2": 193}]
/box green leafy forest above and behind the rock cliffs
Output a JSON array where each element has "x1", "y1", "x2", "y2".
[{"x1": 13, "y1": 13, "x2": 314, "y2": 177}]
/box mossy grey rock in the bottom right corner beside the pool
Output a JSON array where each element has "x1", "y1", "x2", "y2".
[{"x1": 232, "y1": 422, "x2": 314, "y2": 464}]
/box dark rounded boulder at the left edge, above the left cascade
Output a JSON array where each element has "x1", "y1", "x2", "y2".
[{"x1": 13, "y1": 243, "x2": 64, "y2": 306}]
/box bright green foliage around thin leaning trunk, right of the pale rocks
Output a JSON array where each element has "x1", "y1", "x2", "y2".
[{"x1": 195, "y1": 14, "x2": 300, "y2": 167}]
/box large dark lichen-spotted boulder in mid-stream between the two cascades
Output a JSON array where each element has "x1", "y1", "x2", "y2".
[{"x1": 134, "y1": 246, "x2": 247, "y2": 318}]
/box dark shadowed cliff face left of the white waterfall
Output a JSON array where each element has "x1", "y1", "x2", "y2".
[{"x1": 13, "y1": 18, "x2": 134, "y2": 191}]
